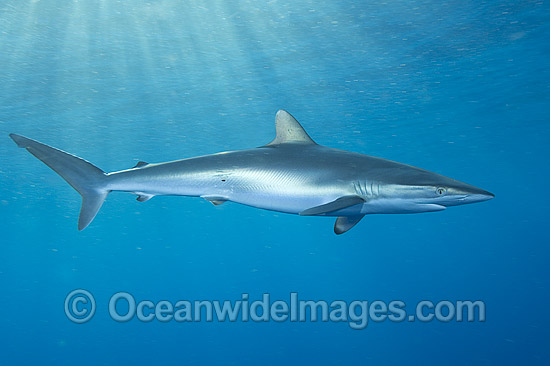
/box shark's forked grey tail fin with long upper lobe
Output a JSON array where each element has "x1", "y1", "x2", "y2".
[{"x1": 10, "y1": 133, "x2": 110, "y2": 230}]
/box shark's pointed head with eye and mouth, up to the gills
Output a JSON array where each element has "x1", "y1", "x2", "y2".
[{"x1": 367, "y1": 163, "x2": 495, "y2": 213}]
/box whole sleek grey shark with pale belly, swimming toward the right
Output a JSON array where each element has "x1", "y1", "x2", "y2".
[{"x1": 10, "y1": 110, "x2": 494, "y2": 234}]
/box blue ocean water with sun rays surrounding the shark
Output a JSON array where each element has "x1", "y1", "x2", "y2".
[{"x1": 0, "y1": 0, "x2": 550, "y2": 365}]
